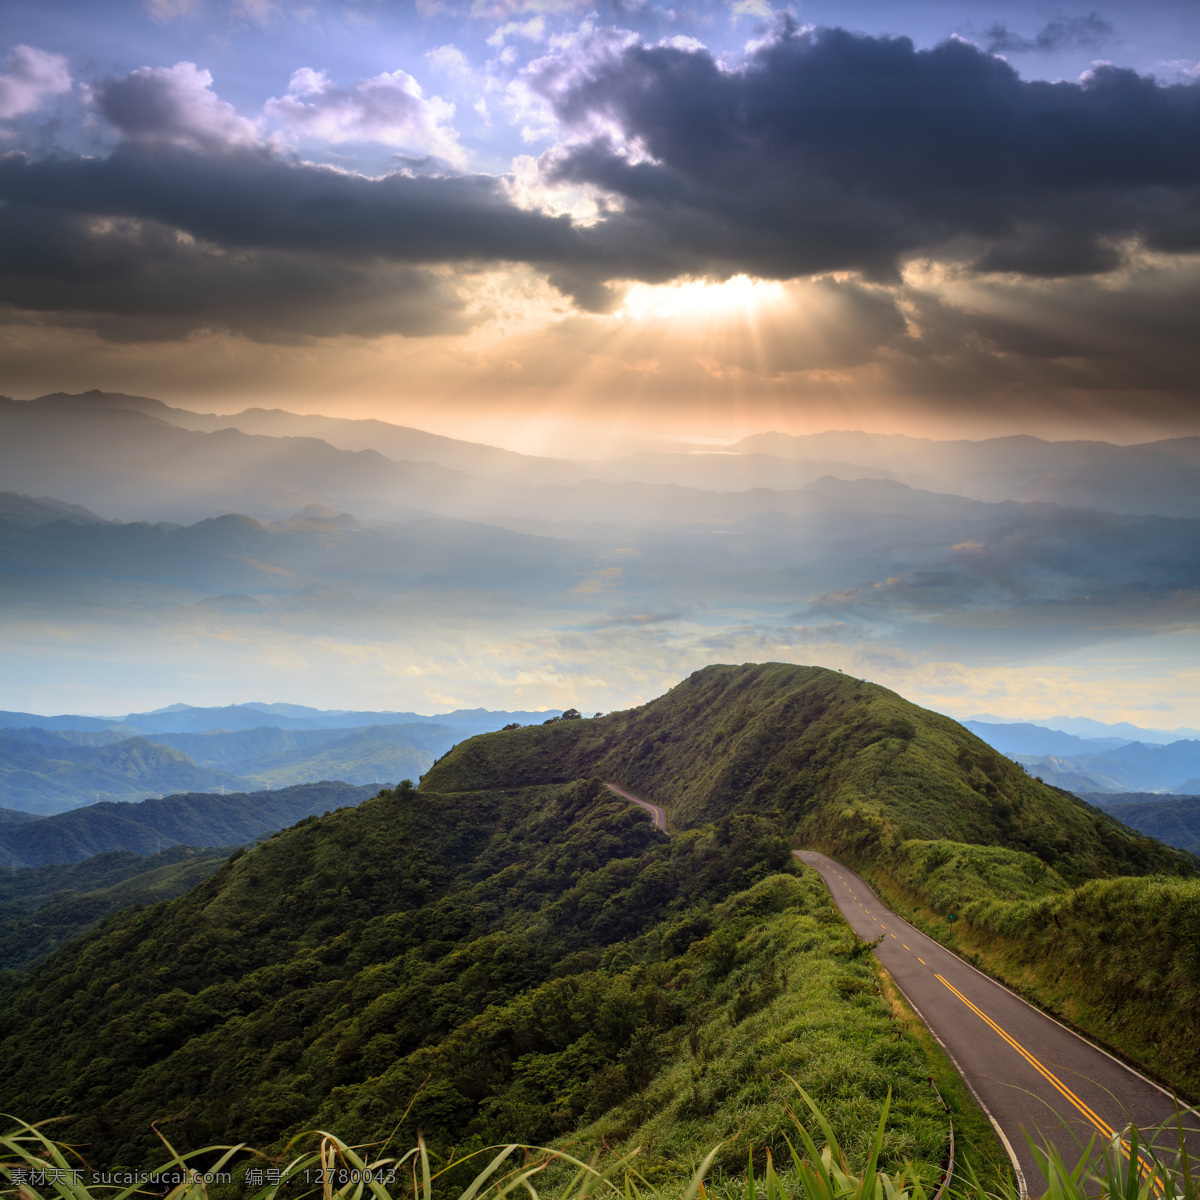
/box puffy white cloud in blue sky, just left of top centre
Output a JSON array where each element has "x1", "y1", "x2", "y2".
[{"x1": 265, "y1": 67, "x2": 466, "y2": 167}]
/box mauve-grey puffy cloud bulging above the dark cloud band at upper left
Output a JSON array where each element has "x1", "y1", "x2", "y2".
[{"x1": 92, "y1": 62, "x2": 262, "y2": 151}]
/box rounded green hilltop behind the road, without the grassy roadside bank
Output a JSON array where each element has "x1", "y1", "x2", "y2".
[{"x1": 422, "y1": 662, "x2": 1190, "y2": 882}]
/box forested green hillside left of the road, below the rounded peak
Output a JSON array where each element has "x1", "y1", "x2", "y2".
[{"x1": 0, "y1": 780, "x2": 988, "y2": 1178}]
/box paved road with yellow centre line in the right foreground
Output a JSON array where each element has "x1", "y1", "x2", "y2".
[{"x1": 792, "y1": 849, "x2": 1200, "y2": 1195}]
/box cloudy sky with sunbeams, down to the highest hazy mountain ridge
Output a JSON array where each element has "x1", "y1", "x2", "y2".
[{"x1": 0, "y1": 0, "x2": 1200, "y2": 454}]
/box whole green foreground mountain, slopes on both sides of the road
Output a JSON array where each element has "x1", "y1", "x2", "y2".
[{"x1": 0, "y1": 664, "x2": 1200, "y2": 1181}]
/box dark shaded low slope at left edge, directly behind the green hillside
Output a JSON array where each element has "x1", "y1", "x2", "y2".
[{"x1": 0, "y1": 846, "x2": 234, "y2": 972}]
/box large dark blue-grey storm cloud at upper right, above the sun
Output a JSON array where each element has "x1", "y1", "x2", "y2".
[{"x1": 530, "y1": 25, "x2": 1200, "y2": 295}]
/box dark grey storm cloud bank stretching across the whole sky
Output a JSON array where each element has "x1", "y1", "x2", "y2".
[{"x1": 0, "y1": 23, "x2": 1200, "y2": 337}]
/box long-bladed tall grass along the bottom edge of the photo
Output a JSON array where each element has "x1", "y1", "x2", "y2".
[{"x1": 7, "y1": 1079, "x2": 1200, "y2": 1200}]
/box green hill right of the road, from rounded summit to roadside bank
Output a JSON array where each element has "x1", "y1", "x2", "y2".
[{"x1": 422, "y1": 664, "x2": 1200, "y2": 1094}]
